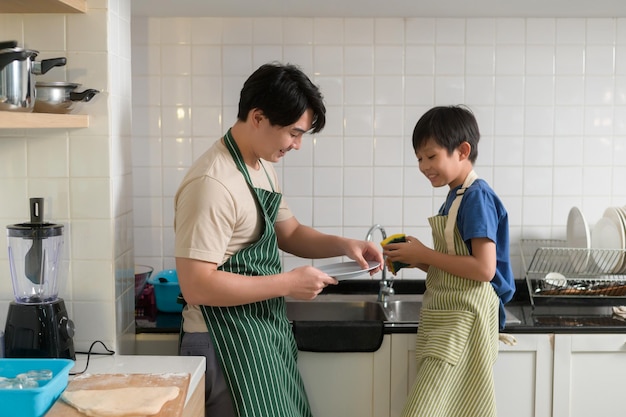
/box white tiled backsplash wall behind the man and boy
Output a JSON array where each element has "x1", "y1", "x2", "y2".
[{"x1": 131, "y1": 17, "x2": 626, "y2": 278}]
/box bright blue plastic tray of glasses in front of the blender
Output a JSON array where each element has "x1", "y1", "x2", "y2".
[{"x1": 0, "y1": 358, "x2": 74, "y2": 417}]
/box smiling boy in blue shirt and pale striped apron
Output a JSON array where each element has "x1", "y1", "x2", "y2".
[{"x1": 383, "y1": 106, "x2": 515, "y2": 417}]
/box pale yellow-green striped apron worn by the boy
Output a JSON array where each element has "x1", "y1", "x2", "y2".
[{"x1": 402, "y1": 171, "x2": 499, "y2": 417}]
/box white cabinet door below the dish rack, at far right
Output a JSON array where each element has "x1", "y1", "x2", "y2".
[{"x1": 553, "y1": 334, "x2": 626, "y2": 417}]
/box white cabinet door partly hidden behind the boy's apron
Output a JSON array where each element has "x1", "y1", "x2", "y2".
[{"x1": 390, "y1": 334, "x2": 553, "y2": 417}]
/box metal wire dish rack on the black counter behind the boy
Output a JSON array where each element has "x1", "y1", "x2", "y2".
[{"x1": 520, "y1": 239, "x2": 626, "y2": 306}]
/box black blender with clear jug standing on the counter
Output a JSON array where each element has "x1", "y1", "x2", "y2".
[{"x1": 4, "y1": 198, "x2": 75, "y2": 360}]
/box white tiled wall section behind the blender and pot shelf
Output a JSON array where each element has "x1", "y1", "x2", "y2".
[{"x1": 0, "y1": 0, "x2": 134, "y2": 353}]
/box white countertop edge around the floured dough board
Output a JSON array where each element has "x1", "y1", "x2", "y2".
[{"x1": 70, "y1": 354, "x2": 206, "y2": 416}]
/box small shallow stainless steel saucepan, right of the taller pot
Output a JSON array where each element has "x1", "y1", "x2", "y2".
[{"x1": 35, "y1": 81, "x2": 99, "y2": 113}]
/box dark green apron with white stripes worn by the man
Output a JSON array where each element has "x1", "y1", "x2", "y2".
[{"x1": 201, "y1": 130, "x2": 311, "y2": 417}]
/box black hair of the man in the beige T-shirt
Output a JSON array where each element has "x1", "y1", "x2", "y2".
[{"x1": 237, "y1": 62, "x2": 326, "y2": 133}]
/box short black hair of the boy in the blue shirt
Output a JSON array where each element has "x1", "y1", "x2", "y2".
[{"x1": 413, "y1": 106, "x2": 480, "y2": 164}]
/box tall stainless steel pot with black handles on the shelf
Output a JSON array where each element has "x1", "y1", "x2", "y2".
[{"x1": 0, "y1": 41, "x2": 67, "y2": 112}]
